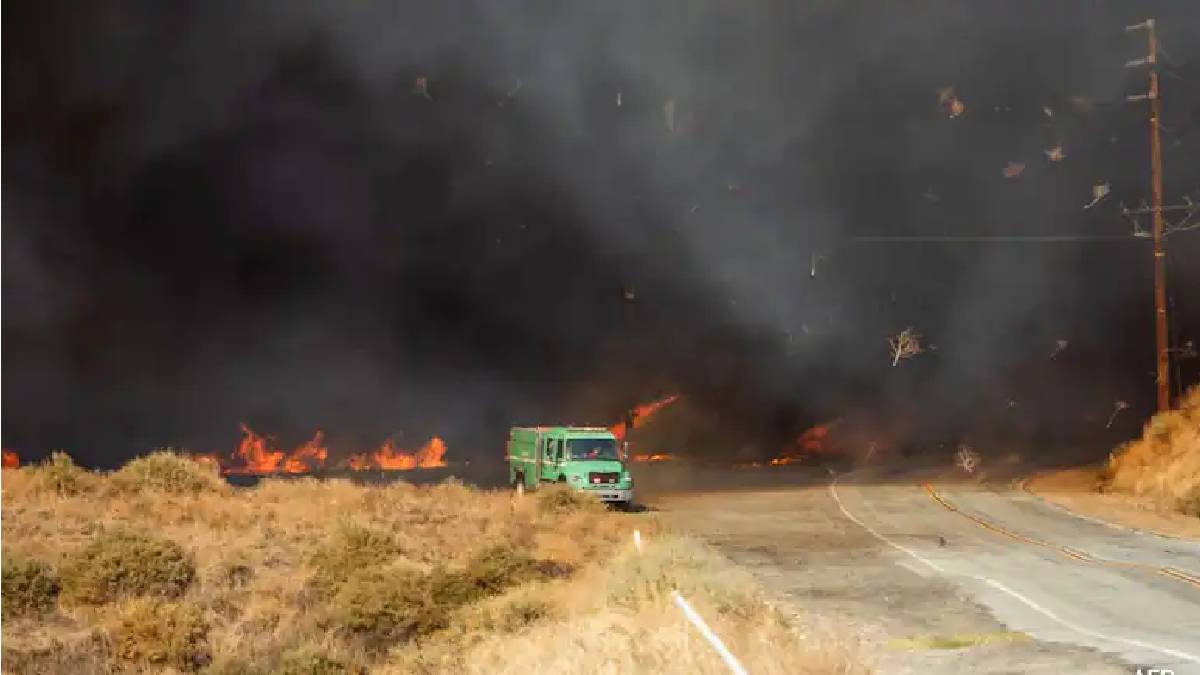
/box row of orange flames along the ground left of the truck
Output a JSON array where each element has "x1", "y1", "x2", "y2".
[{"x1": 192, "y1": 424, "x2": 446, "y2": 476}]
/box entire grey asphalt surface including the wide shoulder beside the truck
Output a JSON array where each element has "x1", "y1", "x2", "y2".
[{"x1": 648, "y1": 468, "x2": 1200, "y2": 675}]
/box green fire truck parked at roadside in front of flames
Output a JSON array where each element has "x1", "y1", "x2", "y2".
[{"x1": 506, "y1": 426, "x2": 634, "y2": 506}]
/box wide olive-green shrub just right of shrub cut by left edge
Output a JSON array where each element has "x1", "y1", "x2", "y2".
[{"x1": 61, "y1": 531, "x2": 196, "y2": 604}]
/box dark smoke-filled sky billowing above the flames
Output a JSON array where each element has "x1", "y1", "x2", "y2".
[{"x1": 2, "y1": 0, "x2": 1200, "y2": 465}]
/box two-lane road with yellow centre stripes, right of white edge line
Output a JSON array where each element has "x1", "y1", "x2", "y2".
[{"x1": 830, "y1": 480, "x2": 1200, "y2": 673}]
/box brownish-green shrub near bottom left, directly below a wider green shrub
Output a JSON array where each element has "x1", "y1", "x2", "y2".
[{"x1": 109, "y1": 598, "x2": 211, "y2": 670}]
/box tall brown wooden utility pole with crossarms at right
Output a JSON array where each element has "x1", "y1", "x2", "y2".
[{"x1": 1126, "y1": 19, "x2": 1171, "y2": 412}]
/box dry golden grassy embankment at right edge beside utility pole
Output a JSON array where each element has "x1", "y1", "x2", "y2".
[{"x1": 1102, "y1": 387, "x2": 1200, "y2": 516}]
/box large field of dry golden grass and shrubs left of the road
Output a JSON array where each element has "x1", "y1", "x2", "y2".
[{"x1": 2, "y1": 454, "x2": 864, "y2": 674}]
